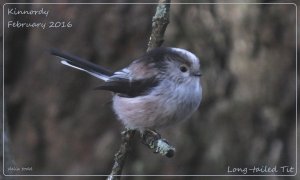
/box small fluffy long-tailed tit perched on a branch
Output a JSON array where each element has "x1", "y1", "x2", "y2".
[{"x1": 51, "y1": 48, "x2": 202, "y2": 130}]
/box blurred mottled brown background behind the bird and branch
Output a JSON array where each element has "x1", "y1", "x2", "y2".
[{"x1": 1, "y1": 0, "x2": 298, "y2": 180}]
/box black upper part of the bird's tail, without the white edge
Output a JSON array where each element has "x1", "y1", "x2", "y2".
[{"x1": 50, "y1": 49, "x2": 113, "y2": 76}]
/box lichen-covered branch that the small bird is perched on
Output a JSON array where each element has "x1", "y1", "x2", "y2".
[{"x1": 107, "y1": 0, "x2": 175, "y2": 180}]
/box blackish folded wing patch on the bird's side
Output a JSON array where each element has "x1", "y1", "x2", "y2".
[{"x1": 95, "y1": 78, "x2": 159, "y2": 98}]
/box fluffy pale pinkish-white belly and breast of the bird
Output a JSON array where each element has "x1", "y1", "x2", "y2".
[{"x1": 113, "y1": 81, "x2": 201, "y2": 129}]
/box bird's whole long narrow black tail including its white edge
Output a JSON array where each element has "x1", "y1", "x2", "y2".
[{"x1": 50, "y1": 49, "x2": 113, "y2": 81}]
